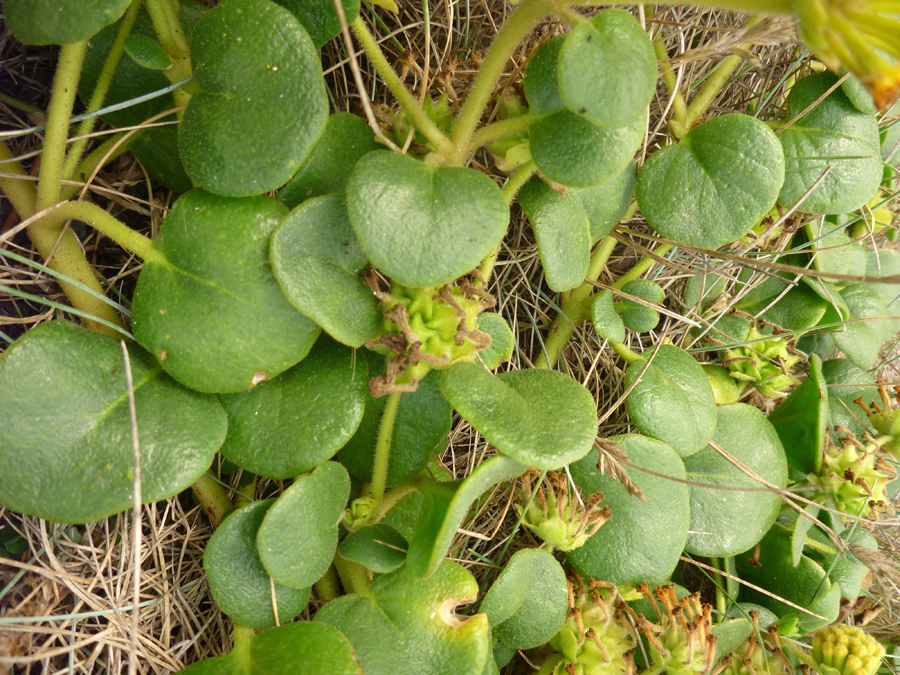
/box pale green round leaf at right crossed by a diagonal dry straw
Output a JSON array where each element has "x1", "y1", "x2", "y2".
[{"x1": 684, "y1": 403, "x2": 788, "y2": 556}]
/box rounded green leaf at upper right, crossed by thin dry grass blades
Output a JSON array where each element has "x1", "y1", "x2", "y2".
[{"x1": 778, "y1": 73, "x2": 882, "y2": 213}]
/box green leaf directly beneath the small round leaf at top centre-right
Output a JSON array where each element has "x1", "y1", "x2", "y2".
[{"x1": 529, "y1": 110, "x2": 646, "y2": 187}]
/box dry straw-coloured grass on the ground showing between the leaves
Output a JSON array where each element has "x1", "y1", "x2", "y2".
[{"x1": 0, "y1": 0, "x2": 900, "y2": 675}]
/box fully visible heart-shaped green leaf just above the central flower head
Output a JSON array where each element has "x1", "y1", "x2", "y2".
[{"x1": 347, "y1": 152, "x2": 509, "y2": 287}]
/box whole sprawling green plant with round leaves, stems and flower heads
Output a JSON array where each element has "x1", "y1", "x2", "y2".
[{"x1": 0, "y1": 0, "x2": 900, "y2": 675}]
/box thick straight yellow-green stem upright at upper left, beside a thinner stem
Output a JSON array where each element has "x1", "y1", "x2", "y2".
[{"x1": 35, "y1": 40, "x2": 87, "y2": 211}]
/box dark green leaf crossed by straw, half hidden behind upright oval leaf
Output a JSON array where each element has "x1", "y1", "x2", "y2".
[{"x1": 203, "y1": 499, "x2": 310, "y2": 628}]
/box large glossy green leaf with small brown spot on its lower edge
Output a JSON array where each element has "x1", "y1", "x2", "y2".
[{"x1": 131, "y1": 190, "x2": 319, "y2": 393}]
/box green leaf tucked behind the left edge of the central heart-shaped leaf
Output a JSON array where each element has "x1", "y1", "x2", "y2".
[{"x1": 269, "y1": 195, "x2": 383, "y2": 347}]
